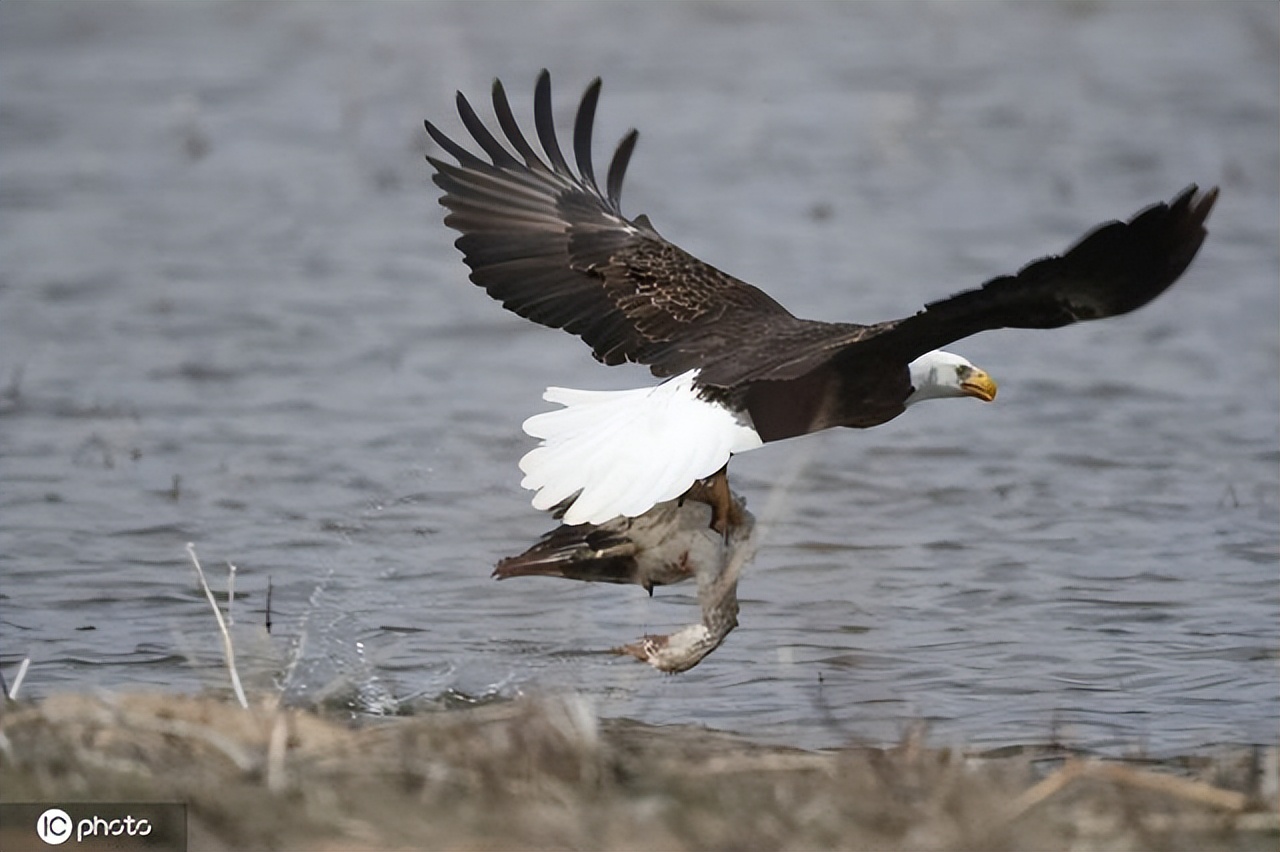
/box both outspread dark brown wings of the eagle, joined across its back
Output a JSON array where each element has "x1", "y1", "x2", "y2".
[{"x1": 426, "y1": 70, "x2": 1217, "y2": 388}]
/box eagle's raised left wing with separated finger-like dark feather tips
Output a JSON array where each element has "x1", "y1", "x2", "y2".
[{"x1": 426, "y1": 70, "x2": 800, "y2": 376}]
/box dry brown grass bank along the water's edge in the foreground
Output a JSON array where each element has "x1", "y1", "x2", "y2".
[{"x1": 0, "y1": 693, "x2": 1280, "y2": 849}]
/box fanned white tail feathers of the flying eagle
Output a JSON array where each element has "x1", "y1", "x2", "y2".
[{"x1": 520, "y1": 370, "x2": 760, "y2": 523}]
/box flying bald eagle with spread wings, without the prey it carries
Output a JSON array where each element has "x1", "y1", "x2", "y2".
[{"x1": 426, "y1": 70, "x2": 1217, "y2": 532}]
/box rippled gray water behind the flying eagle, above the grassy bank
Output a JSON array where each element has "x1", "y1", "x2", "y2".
[{"x1": 0, "y1": 1, "x2": 1280, "y2": 752}]
